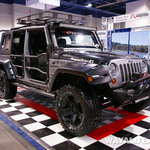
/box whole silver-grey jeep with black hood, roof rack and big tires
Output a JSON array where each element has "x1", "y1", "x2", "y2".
[{"x1": 0, "y1": 12, "x2": 150, "y2": 136}]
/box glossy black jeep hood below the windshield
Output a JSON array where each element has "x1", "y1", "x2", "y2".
[{"x1": 61, "y1": 50, "x2": 138, "y2": 64}]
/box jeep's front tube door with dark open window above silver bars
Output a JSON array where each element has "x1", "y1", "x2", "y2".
[{"x1": 25, "y1": 28, "x2": 48, "y2": 83}]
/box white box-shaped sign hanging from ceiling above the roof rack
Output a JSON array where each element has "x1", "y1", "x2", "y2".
[{"x1": 26, "y1": 0, "x2": 60, "y2": 10}]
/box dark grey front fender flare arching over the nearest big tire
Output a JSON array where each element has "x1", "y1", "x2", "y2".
[{"x1": 50, "y1": 63, "x2": 112, "y2": 91}]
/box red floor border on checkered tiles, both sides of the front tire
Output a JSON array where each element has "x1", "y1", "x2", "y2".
[{"x1": 15, "y1": 94, "x2": 148, "y2": 140}]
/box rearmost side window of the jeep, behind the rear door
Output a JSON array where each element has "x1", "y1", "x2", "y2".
[{"x1": 2, "y1": 34, "x2": 11, "y2": 50}]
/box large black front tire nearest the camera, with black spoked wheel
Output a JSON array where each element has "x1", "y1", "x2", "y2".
[{"x1": 56, "y1": 85, "x2": 102, "y2": 136}]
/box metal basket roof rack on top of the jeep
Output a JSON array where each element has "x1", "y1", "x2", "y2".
[{"x1": 17, "y1": 10, "x2": 86, "y2": 26}]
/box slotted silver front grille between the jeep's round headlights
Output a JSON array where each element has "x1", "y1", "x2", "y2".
[{"x1": 120, "y1": 63, "x2": 142, "y2": 82}]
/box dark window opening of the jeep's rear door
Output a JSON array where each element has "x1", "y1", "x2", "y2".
[{"x1": 12, "y1": 31, "x2": 25, "y2": 55}]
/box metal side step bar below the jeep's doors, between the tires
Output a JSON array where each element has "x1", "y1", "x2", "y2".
[{"x1": 12, "y1": 82, "x2": 55, "y2": 99}]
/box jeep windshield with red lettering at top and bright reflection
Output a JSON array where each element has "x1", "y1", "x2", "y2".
[{"x1": 55, "y1": 28, "x2": 99, "y2": 48}]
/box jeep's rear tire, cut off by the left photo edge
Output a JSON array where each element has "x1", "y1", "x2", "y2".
[{"x1": 0, "y1": 70, "x2": 17, "y2": 99}]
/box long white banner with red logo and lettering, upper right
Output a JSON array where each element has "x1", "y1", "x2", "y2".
[{"x1": 113, "y1": 11, "x2": 150, "y2": 23}]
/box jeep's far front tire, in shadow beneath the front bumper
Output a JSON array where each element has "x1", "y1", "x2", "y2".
[{"x1": 122, "y1": 100, "x2": 150, "y2": 112}]
